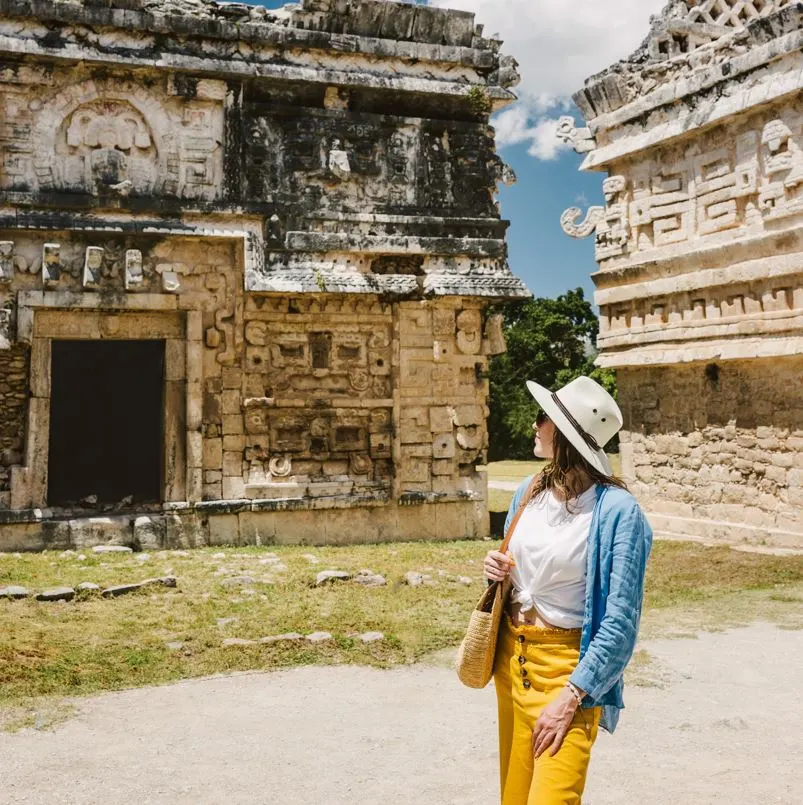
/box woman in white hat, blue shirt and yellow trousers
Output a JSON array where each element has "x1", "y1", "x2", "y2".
[{"x1": 484, "y1": 377, "x2": 652, "y2": 805}]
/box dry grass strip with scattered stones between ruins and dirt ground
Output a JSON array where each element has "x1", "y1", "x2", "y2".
[{"x1": 0, "y1": 542, "x2": 803, "y2": 716}]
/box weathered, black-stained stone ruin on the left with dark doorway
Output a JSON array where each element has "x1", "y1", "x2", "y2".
[{"x1": 0, "y1": 0, "x2": 528, "y2": 550}]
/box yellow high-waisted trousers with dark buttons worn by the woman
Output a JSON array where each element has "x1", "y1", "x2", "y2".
[{"x1": 494, "y1": 617, "x2": 600, "y2": 805}]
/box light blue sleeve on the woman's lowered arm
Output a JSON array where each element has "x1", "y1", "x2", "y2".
[{"x1": 570, "y1": 505, "x2": 652, "y2": 700}]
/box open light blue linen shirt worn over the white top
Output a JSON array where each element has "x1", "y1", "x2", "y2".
[{"x1": 505, "y1": 476, "x2": 652, "y2": 732}]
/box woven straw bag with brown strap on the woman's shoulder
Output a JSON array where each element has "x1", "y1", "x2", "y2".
[{"x1": 456, "y1": 478, "x2": 537, "y2": 688}]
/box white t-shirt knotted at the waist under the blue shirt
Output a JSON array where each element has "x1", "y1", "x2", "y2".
[{"x1": 509, "y1": 485, "x2": 597, "y2": 629}]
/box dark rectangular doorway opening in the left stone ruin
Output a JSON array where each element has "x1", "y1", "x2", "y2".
[{"x1": 48, "y1": 341, "x2": 164, "y2": 506}]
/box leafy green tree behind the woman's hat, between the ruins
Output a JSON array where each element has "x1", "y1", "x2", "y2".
[{"x1": 488, "y1": 288, "x2": 616, "y2": 461}]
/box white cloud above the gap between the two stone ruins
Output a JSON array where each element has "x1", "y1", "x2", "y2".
[{"x1": 430, "y1": 0, "x2": 667, "y2": 159}]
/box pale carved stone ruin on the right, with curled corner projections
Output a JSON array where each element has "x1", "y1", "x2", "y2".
[{"x1": 559, "y1": 0, "x2": 803, "y2": 548}]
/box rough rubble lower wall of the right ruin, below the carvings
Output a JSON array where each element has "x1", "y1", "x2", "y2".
[{"x1": 617, "y1": 356, "x2": 803, "y2": 547}]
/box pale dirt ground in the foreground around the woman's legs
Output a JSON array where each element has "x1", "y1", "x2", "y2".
[{"x1": 0, "y1": 624, "x2": 803, "y2": 805}]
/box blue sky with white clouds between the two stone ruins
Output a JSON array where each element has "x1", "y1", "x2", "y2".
[{"x1": 260, "y1": 0, "x2": 667, "y2": 299}]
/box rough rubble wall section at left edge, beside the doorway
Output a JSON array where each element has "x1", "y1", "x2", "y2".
[{"x1": 0, "y1": 346, "x2": 28, "y2": 506}]
